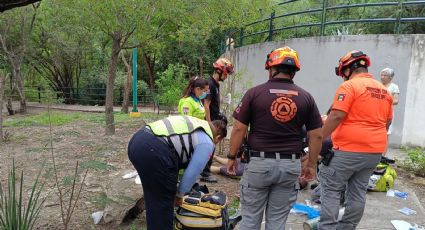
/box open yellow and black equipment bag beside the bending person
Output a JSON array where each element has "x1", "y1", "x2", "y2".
[{"x1": 174, "y1": 191, "x2": 229, "y2": 230}]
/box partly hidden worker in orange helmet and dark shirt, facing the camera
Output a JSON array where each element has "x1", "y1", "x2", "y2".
[{"x1": 201, "y1": 58, "x2": 234, "y2": 183}]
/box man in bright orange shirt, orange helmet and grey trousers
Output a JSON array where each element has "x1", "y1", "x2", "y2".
[{"x1": 318, "y1": 50, "x2": 392, "y2": 230}]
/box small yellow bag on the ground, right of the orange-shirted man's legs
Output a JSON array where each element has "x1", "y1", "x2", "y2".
[{"x1": 367, "y1": 161, "x2": 397, "y2": 192}]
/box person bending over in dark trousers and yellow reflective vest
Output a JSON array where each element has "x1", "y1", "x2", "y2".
[{"x1": 128, "y1": 116, "x2": 227, "y2": 230}]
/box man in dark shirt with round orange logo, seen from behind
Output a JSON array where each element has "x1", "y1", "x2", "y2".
[{"x1": 227, "y1": 47, "x2": 322, "y2": 230}]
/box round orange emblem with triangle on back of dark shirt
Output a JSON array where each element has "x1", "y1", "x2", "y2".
[{"x1": 270, "y1": 97, "x2": 298, "y2": 123}]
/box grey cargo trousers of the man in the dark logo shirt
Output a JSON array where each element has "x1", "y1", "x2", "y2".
[{"x1": 240, "y1": 157, "x2": 301, "y2": 230}]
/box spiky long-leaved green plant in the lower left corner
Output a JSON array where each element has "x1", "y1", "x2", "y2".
[{"x1": 0, "y1": 161, "x2": 45, "y2": 230}]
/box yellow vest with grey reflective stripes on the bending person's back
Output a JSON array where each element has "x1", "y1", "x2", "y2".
[{"x1": 147, "y1": 116, "x2": 214, "y2": 140}]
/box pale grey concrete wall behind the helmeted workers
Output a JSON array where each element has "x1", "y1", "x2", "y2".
[{"x1": 224, "y1": 35, "x2": 425, "y2": 146}]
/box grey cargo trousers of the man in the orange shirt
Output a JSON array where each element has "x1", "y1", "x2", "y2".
[{"x1": 318, "y1": 150, "x2": 381, "y2": 230}]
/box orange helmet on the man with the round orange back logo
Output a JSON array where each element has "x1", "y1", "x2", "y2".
[{"x1": 265, "y1": 46, "x2": 301, "y2": 71}]
